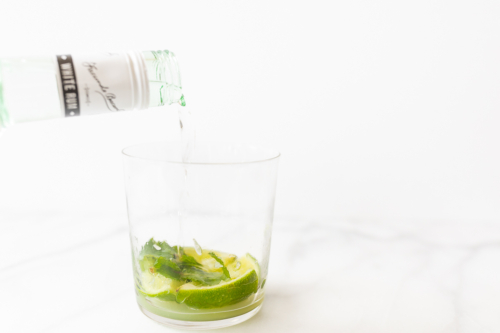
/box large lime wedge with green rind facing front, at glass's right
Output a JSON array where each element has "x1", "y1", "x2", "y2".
[{"x1": 177, "y1": 267, "x2": 259, "y2": 309}]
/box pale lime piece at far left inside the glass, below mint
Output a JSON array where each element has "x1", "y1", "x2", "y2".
[{"x1": 137, "y1": 271, "x2": 182, "y2": 301}]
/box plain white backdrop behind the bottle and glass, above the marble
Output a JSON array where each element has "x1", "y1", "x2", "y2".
[{"x1": 0, "y1": 0, "x2": 500, "y2": 220}]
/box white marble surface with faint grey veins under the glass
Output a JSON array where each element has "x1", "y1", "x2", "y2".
[{"x1": 0, "y1": 212, "x2": 500, "y2": 333}]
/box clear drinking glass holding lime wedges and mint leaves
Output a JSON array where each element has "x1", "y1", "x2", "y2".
[{"x1": 123, "y1": 143, "x2": 279, "y2": 329}]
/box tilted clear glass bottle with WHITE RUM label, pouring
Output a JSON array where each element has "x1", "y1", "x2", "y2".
[{"x1": 0, "y1": 50, "x2": 185, "y2": 129}]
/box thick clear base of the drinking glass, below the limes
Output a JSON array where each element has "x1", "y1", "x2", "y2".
[{"x1": 138, "y1": 304, "x2": 262, "y2": 331}]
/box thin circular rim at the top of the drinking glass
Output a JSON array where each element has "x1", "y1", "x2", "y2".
[{"x1": 121, "y1": 141, "x2": 281, "y2": 166}]
